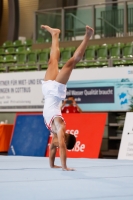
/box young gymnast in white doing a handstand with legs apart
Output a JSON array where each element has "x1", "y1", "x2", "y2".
[{"x1": 41, "y1": 25, "x2": 93, "y2": 171}]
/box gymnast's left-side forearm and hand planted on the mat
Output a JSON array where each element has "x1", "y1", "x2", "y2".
[{"x1": 49, "y1": 142, "x2": 62, "y2": 168}]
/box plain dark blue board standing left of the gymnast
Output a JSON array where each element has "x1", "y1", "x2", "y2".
[{"x1": 8, "y1": 114, "x2": 50, "y2": 156}]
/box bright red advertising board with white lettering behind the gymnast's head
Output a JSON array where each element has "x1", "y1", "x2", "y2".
[{"x1": 46, "y1": 113, "x2": 107, "y2": 158}]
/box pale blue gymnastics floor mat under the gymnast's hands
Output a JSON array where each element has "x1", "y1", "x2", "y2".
[{"x1": 0, "y1": 156, "x2": 133, "y2": 200}]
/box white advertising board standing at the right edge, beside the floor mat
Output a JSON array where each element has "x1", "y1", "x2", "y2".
[{"x1": 118, "y1": 112, "x2": 133, "y2": 160}]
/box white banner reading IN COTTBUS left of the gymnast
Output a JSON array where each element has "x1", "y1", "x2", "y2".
[{"x1": 0, "y1": 72, "x2": 44, "y2": 112}]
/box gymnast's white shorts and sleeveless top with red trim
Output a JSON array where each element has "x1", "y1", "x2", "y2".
[{"x1": 42, "y1": 80, "x2": 66, "y2": 132}]
